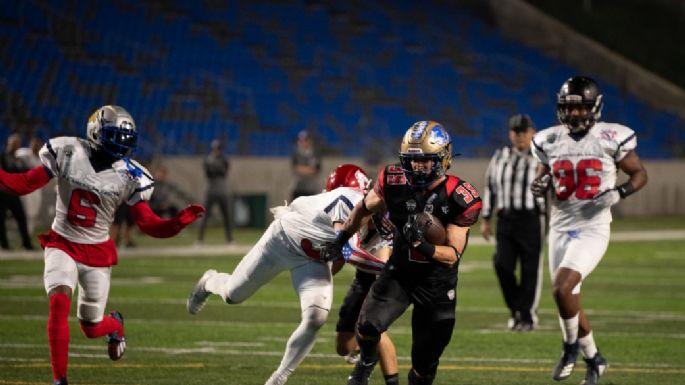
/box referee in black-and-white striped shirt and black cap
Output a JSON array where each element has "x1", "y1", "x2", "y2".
[{"x1": 481, "y1": 114, "x2": 546, "y2": 331}]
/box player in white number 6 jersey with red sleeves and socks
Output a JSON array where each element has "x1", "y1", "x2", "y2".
[{"x1": 0, "y1": 105, "x2": 204, "y2": 385}]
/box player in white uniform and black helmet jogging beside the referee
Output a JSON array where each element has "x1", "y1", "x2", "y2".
[{"x1": 531, "y1": 76, "x2": 647, "y2": 385}]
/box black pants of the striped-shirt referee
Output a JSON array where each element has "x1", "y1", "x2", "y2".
[{"x1": 493, "y1": 211, "x2": 545, "y2": 323}]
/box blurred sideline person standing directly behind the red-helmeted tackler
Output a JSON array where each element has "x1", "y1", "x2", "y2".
[{"x1": 290, "y1": 130, "x2": 321, "y2": 200}]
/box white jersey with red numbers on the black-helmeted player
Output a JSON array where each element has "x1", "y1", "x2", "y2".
[{"x1": 533, "y1": 122, "x2": 637, "y2": 231}]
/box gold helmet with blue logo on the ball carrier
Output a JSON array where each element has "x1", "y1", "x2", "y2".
[{"x1": 400, "y1": 120, "x2": 452, "y2": 187}]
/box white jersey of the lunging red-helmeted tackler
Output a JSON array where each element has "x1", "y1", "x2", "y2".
[{"x1": 277, "y1": 187, "x2": 364, "y2": 255}]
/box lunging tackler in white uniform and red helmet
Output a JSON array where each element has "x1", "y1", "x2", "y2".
[{"x1": 186, "y1": 164, "x2": 369, "y2": 385}]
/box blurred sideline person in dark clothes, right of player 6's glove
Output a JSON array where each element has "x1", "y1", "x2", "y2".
[{"x1": 197, "y1": 139, "x2": 233, "y2": 244}]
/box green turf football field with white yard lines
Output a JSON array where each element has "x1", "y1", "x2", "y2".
[{"x1": 0, "y1": 218, "x2": 685, "y2": 385}]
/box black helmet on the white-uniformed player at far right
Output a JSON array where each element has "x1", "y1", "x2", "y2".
[{"x1": 557, "y1": 76, "x2": 604, "y2": 134}]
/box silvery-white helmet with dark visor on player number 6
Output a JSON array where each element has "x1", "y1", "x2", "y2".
[{"x1": 86, "y1": 105, "x2": 138, "y2": 159}]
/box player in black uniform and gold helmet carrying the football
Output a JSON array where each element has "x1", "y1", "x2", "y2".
[{"x1": 324, "y1": 121, "x2": 482, "y2": 385}]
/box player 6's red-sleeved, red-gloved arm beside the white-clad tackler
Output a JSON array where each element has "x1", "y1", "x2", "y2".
[{"x1": 129, "y1": 201, "x2": 205, "y2": 238}]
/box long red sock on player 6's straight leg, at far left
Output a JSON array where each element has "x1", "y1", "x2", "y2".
[{"x1": 48, "y1": 293, "x2": 71, "y2": 380}]
